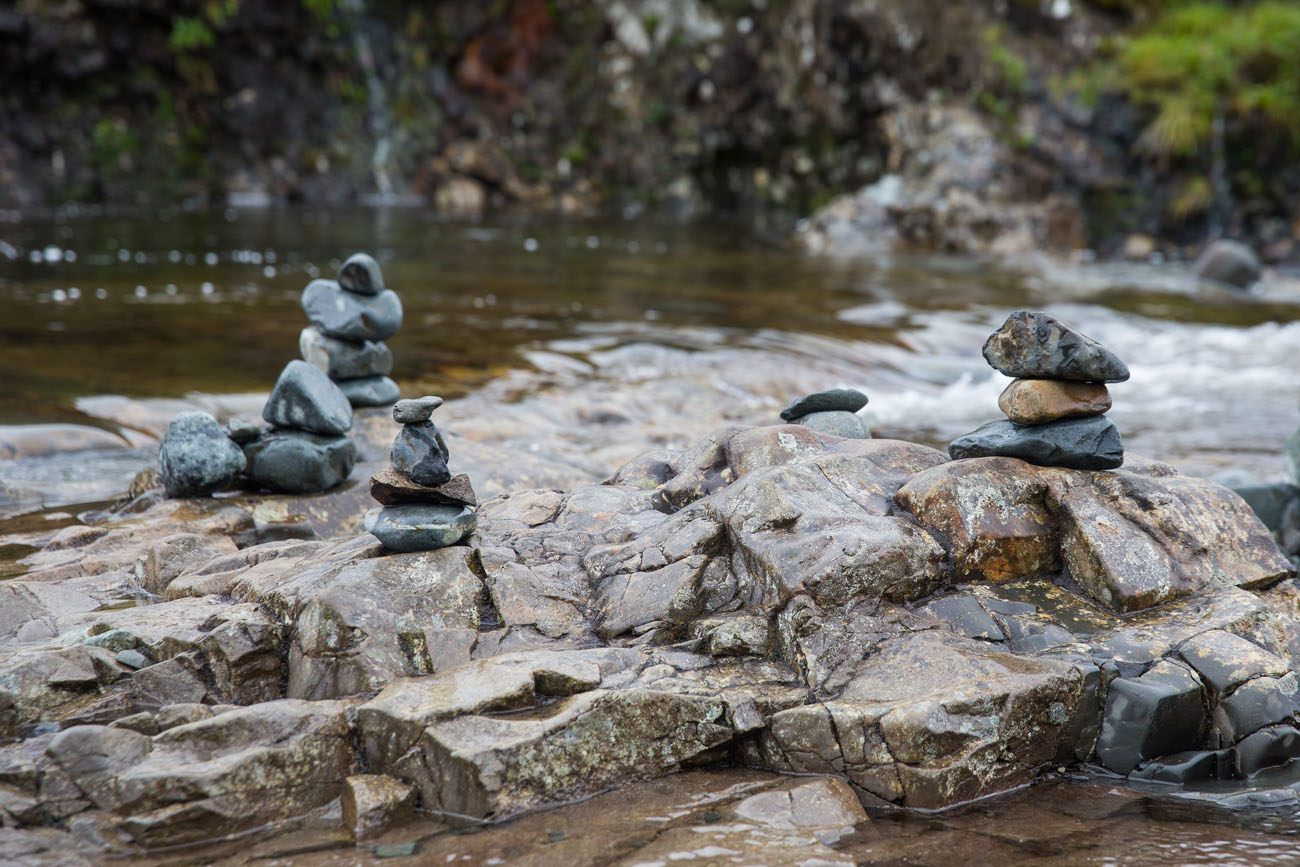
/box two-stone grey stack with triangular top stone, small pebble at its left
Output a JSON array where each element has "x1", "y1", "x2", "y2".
[{"x1": 241, "y1": 361, "x2": 356, "y2": 494}]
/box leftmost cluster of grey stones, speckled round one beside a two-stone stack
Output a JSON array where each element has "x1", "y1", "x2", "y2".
[{"x1": 159, "y1": 361, "x2": 356, "y2": 497}]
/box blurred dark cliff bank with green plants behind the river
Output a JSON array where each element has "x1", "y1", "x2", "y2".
[{"x1": 0, "y1": 0, "x2": 1300, "y2": 261}]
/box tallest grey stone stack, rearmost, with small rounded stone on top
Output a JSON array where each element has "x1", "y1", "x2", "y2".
[{"x1": 298, "y1": 253, "x2": 402, "y2": 407}]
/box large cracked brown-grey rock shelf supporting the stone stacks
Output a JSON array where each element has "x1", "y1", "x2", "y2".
[{"x1": 0, "y1": 425, "x2": 1300, "y2": 853}]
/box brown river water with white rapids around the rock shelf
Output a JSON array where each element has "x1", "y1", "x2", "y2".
[{"x1": 0, "y1": 209, "x2": 1300, "y2": 864}]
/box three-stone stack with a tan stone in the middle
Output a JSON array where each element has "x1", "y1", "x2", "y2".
[{"x1": 948, "y1": 311, "x2": 1128, "y2": 469}]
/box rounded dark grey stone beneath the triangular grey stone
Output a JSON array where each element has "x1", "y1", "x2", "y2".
[{"x1": 244, "y1": 430, "x2": 356, "y2": 494}]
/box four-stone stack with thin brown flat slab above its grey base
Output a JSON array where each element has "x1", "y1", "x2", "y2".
[{"x1": 365, "y1": 396, "x2": 478, "y2": 551}]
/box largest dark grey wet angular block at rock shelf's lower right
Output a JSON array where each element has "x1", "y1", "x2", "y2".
[{"x1": 1097, "y1": 660, "x2": 1205, "y2": 773}]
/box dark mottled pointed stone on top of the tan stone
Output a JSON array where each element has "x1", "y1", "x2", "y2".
[{"x1": 984, "y1": 311, "x2": 1128, "y2": 382}]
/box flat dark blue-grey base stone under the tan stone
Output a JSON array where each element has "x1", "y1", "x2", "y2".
[{"x1": 948, "y1": 416, "x2": 1125, "y2": 469}]
